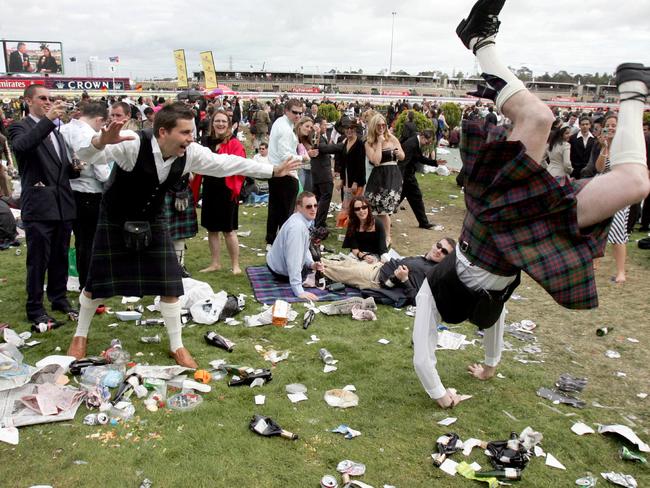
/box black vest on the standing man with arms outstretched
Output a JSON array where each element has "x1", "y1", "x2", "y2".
[{"x1": 102, "y1": 129, "x2": 185, "y2": 222}]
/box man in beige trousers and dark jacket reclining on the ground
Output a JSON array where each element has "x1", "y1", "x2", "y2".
[{"x1": 323, "y1": 237, "x2": 456, "y2": 306}]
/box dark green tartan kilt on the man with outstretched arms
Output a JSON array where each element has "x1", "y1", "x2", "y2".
[{"x1": 85, "y1": 211, "x2": 183, "y2": 298}]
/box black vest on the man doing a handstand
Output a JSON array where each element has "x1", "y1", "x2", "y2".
[{"x1": 427, "y1": 251, "x2": 521, "y2": 329}]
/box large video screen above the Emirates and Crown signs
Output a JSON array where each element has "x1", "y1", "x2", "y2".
[{"x1": 2, "y1": 41, "x2": 64, "y2": 75}]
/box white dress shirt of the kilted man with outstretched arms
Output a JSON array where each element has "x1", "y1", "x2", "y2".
[{"x1": 77, "y1": 130, "x2": 273, "y2": 183}]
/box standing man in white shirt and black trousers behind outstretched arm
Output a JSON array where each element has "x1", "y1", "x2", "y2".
[{"x1": 266, "y1": 98, "x2": 309, "y2": 249}]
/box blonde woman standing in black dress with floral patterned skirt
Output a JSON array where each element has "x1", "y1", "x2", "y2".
[{"x1": 365, "y1": 114, "x2": 404, "y2": 244}]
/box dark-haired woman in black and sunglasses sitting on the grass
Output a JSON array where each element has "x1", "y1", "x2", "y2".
[{"x1": 342, "y1": 196, "x2": 389, "y2": 264}]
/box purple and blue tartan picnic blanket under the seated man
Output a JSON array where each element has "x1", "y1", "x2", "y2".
[{"x1": 246, "y1": 266, "x2": 361, "y2": 304}]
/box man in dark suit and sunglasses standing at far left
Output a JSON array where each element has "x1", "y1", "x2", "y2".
[{"x1": 9, "y1": 85, "x2": 77, "y2": 323}]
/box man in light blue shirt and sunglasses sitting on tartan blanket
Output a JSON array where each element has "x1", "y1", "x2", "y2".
[{"x1": 266, "y1": 191, "x2": 323, "y2": 300}]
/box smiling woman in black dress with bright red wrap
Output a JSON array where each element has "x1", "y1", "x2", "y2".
[{"x1": 201, "y1": 110, "x2": 246, "y2": 274}]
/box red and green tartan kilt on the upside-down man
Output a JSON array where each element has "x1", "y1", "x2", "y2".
[{"x1": 460, "y1": 119, "x2": 611, "y2": 309}]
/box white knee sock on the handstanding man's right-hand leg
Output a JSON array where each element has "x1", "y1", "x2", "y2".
[{"x1": 609, "y1": 81, "x2": 648, "y2": 166}]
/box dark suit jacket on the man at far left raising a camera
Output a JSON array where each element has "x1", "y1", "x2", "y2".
[{"x1": 9, "y1": 117, "x2": 78, "y2": 222}]
